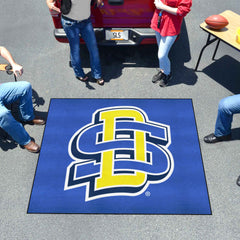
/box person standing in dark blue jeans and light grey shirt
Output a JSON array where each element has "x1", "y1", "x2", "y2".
[{"x1": 46, "y1": 0, "x2": 104, "y2": 85}]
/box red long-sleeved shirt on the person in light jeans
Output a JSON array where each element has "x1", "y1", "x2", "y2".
[{"x1": 151, "y1": 0, "x2": 192, "y2": 37}]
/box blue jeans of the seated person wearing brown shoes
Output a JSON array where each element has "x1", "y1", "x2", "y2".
[{"x1": 0, "y1": 81, "x2": 34, "y2": 145}]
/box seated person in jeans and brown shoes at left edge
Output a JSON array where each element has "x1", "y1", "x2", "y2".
[{"x1": 0, "y1": 47, "x2": 45, "y2": 153}]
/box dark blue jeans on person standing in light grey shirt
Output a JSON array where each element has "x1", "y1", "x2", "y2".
[{"x1": 61, "y1": 17, "x2": 102, "y2": 79}]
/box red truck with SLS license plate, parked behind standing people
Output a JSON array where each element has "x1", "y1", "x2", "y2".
[{"x1": 50, "y1": 0, "x2": 156, "y2": 45}]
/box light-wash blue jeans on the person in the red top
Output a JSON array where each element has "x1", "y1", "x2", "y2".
[{"x1": 155, "y1": 31, "x2": 177, "y2": 75}]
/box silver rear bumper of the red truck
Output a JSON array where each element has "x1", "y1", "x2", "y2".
[{"x1": 54, "y1": 28, "x2": 156, "y2": 46}]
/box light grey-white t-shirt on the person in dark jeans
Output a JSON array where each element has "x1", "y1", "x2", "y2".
[{"x1": 64, "y1": 0, "x2": 91, "y2": 21}]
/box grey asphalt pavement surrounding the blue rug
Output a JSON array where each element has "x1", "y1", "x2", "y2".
[{"x1": 0, "y1": 0, "x2": 240, "y2": 240}]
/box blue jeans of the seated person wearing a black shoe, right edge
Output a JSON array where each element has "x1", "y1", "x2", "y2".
[{"x1": 214, "y1": 94, "x2": 240, "y2": 137}]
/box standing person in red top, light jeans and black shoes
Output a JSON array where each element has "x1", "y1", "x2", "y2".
[{"x1": 151, "y1": 0, "x2": 192, "y2": 87}]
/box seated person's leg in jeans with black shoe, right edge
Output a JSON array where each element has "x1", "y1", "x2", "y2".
[{"x1": 204, "y1": 94, "x2": 240, "y2": 143}]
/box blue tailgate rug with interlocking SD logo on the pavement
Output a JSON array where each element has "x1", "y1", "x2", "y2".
[{"x1": 28, "y1": 99, "x2": 211, "y2": 215}]
